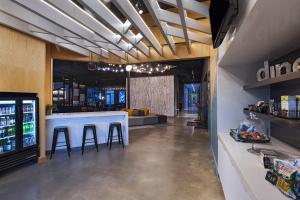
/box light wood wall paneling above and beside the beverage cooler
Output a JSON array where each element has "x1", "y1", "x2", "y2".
[{"x1": 0, "y1": 26, "x2": 46, "y2": 157}]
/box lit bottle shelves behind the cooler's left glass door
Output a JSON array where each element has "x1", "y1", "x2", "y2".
[{"x1": 0, "y1": 101, "x2": 16, "y2": 154}]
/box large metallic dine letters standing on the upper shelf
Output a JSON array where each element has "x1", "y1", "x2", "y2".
[{"x1": 256, "y1": 58, "x2": 300, "y2": 81}]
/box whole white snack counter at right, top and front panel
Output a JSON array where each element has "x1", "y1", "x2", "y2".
[{"x1": 218, "y1": 133, "x2": 300, "y2": 200}]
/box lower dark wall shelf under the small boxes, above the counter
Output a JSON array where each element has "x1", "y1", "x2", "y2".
[{"x1": 244, "y1": 110, "x2": 300, "y2": 128}]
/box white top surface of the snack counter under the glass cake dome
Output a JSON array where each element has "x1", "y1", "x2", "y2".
[{"x1": 218, "y1": 133, "x2": 300, "y2": 200}]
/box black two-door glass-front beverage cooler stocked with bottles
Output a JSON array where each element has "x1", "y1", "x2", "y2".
[{"x1": 0, "y1": 92, "x2": 39, "y2": 172}]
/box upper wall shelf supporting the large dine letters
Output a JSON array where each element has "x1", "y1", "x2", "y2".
[{"x1": 244, "y1": 71, "x2": 300, "y2": 90}]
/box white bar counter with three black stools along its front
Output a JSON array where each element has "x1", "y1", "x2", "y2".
[{"x1": 46, "y1": 111, "x2": 128, "y2": 150}]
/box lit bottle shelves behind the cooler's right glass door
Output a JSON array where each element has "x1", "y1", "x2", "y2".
[{"x1": 23, "y1": 100, "x2": 36, "y2": 147}]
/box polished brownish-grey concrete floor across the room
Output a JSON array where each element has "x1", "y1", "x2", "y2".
[{"x1": 0, "y1": 119, "x2": 224, "y2": 200}]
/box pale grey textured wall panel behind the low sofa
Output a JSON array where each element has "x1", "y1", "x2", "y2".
[{"x1": 130, "y1": 76, "x2": 175, "y2": 116}]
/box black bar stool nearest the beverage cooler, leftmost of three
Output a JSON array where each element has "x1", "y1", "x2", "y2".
[{"x1": 50, "y1": 126, "x2": 71, "y2": 159}]
